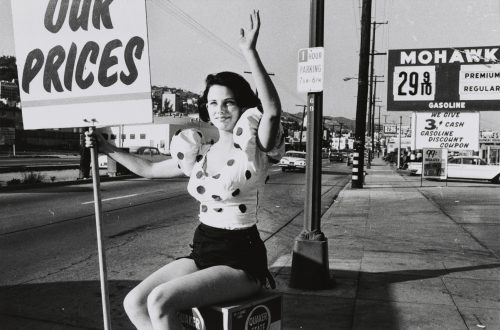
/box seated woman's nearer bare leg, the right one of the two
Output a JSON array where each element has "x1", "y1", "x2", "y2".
[{"x1": 147, "y1": 266, "x2": 261, "y2": 330}]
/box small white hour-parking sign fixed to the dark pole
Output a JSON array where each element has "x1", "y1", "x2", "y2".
[{"x1": 297, "y1": 47, "x2": 325, "y2": 93}]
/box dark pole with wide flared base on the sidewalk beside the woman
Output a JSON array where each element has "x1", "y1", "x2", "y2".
[{"x1": 290, "y1": 0, "x2": 331, "y2": 290}]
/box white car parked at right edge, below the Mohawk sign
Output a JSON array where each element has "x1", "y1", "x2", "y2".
[{"x1": 447, "y1": 156, "x2": 500, "y2": 183}]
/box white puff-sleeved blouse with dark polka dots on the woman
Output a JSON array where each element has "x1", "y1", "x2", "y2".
[{"x1": 170, "y1": 108, "x2": 285, "y2": 229}]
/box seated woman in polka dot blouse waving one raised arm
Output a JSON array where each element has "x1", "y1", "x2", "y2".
[{"x1": 86, "y1": 11, "x2": 284, "y2": 329}]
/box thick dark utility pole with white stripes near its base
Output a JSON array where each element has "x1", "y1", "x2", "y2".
[{"x1": 351, "y1": 0, "x2": 372, "y2": 188}]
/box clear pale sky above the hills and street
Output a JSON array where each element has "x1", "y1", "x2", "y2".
[{"x1": 0, "y1": 0, "x2": 500, "y2": 131}]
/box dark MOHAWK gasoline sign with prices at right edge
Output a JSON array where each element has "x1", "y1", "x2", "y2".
[{"x1": 387, "y1": 46, "x2": 500, "y2": 111}]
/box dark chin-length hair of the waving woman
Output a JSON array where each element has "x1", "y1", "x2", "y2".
[{"x1": 198, "y1": 71, "x2": 261, "y2": 122}]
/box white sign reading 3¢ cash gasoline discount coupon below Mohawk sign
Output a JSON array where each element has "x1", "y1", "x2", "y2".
[{"x1": 415, "y1": 111, "x2": 479, "y2": 151}]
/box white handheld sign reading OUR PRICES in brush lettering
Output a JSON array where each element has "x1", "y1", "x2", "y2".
[{"x1": 11, "y1": 0, "x2": 152, "y2": 129}]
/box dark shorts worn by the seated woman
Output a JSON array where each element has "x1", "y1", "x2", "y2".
[{"x1": 187, "y1": 223, "x2": 275, "y2": 287}]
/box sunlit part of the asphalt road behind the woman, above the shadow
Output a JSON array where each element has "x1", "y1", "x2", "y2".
[{"x1": 0, "y1": 159, "x2": 350, "y2": 286}]
